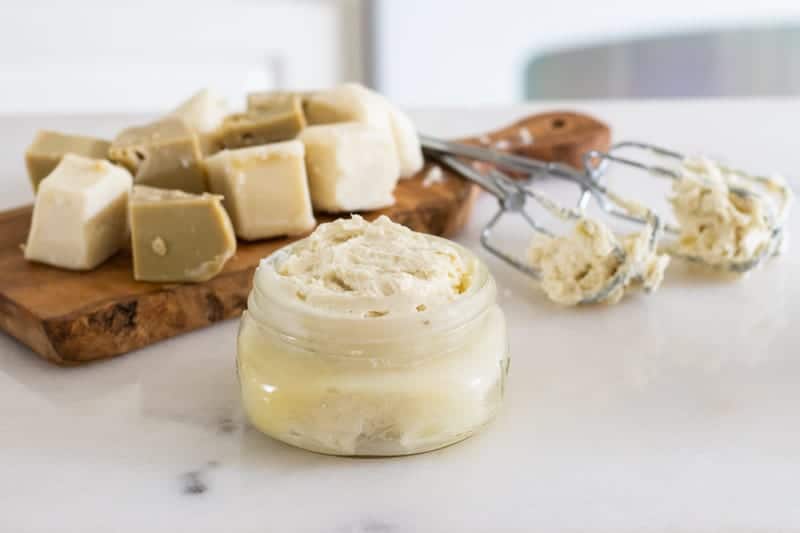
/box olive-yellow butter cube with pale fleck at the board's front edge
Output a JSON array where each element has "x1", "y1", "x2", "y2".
[{"x1": 129, "y1": 185, "x2": 236, "y2": 282}]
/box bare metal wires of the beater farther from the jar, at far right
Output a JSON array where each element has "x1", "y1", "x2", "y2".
[{"x1": 578, "y1": 141, "x2": 793, "y2": 273}]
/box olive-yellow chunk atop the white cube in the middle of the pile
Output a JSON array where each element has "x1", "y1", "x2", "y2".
[{"x1": 216, "y1": 93, "x2": 306, "y2": 149}]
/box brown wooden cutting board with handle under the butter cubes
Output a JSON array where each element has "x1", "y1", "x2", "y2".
[{"x1": 0, "y1": 112, "x2": 610, "y2": 365}]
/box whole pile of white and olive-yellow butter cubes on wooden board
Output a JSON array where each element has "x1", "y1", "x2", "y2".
[{"x1": 25, "y1": 83, "x2": 423, "y2": 282}]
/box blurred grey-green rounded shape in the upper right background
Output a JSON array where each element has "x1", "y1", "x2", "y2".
[{"x1": 524, "y1": 27, "x2": 800, "y2": 99}]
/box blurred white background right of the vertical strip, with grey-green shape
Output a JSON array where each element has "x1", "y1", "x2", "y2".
[{"x1": 375, "y1": 0, "x2": 800, "y2": 107}]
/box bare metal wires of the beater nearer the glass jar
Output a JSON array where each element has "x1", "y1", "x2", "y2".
[{"x1": 421, "y1": 136, "x2": 661, "y2": 304}]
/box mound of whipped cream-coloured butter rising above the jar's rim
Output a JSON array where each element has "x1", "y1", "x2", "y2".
[{"x1": 270, "y1": 215, "x2": 474, "y2": 318}]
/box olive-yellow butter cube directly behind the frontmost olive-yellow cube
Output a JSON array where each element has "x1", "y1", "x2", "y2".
[{"x1": 108, "y1": 116, "x2": 206, "y2": 193}]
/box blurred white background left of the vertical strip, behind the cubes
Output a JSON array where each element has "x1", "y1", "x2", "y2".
[{"x1": 0, "y1": 0, "x2": 364, "y2": 112}]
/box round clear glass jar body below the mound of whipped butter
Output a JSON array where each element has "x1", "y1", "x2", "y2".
[{"x1": 237, "y1": 236, "x2": 509, "y2": 456}]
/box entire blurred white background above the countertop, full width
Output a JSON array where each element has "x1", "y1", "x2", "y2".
[{"x1": 0, "y1": 0, "x2": 800, "y2": 113}]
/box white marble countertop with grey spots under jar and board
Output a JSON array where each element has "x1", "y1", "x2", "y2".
[{"x1": 0, "y1": 100, "x2": 800, "y2": 532}]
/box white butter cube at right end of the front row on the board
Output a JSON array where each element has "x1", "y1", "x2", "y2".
[{"x1": 300, "y1": 122, "x2": 399, "y2": 213}]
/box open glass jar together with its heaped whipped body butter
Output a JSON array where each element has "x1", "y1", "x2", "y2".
[{"x1": 238, "y1": 216, "x2": 508, "y2": 456}]
